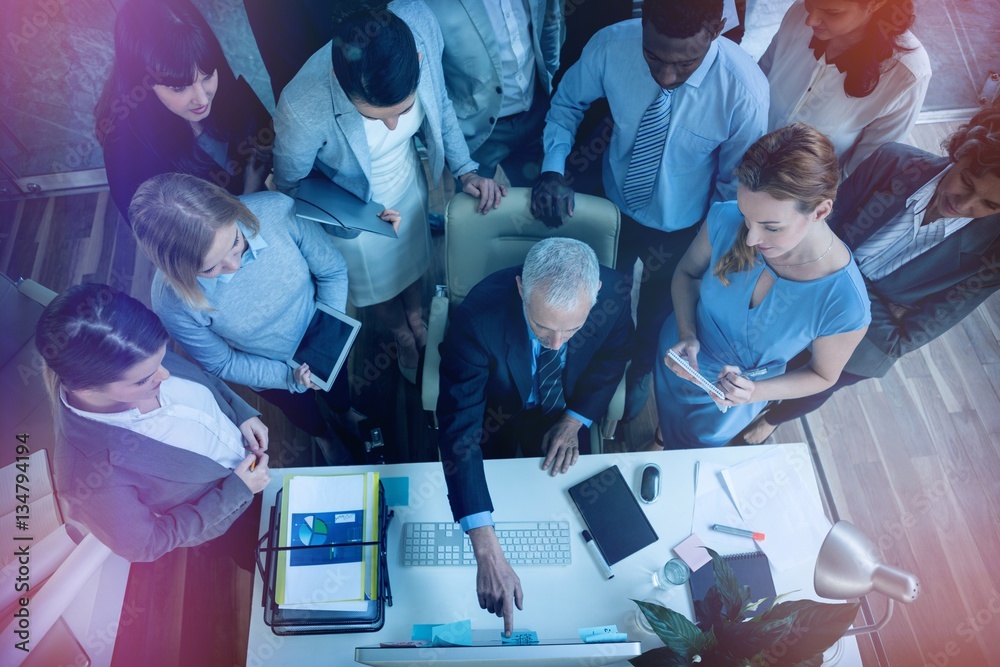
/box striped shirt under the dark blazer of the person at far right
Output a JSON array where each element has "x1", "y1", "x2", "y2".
[{"x1": 854, "y1": 165, "x2": 972, "y2": 281}]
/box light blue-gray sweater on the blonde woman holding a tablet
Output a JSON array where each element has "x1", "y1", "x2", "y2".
[{"x1": 152, "y1": 192, "x2": 347, "y2": 392}]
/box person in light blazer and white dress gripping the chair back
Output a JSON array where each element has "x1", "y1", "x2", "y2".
[{"x1": 274, "y1": 0, "x2": 505, "y2": 382}]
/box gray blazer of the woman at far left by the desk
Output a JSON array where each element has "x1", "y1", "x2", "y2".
[{"x1": 54, "y1": 352, "x2": 260, "y2": 562}]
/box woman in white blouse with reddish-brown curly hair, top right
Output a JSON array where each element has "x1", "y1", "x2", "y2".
[{"x1": 760, "y1": 0, "x2": 931, "y2": 178}]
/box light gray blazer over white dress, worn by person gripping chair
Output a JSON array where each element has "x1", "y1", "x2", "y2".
[{"x1": 274, "y1": 0, "x2": 479, "y2": 196}]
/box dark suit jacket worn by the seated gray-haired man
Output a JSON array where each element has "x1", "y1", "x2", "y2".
[{"x1": 437, "y1": 267, "x2": 634, "y2": 520}]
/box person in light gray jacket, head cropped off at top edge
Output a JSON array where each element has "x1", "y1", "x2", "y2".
[{"x1": 425, "y1": 0, "x2": 563, "y2": 186}]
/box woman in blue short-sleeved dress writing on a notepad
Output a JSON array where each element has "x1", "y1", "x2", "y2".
[{"x1": 654, "y1": 124, "x2": 871, "y2": 449}]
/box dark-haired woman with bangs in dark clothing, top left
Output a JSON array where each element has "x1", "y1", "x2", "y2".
[{"x1": 94, "y1": 0, "x2": 273, "y2": 220}]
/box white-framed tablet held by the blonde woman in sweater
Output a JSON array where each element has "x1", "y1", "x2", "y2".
[{"x1": 288, "y1": 303, "x2": 361, "y2": 391}]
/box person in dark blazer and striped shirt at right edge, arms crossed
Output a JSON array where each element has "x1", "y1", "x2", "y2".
[{"x1": 743, "y1": 103, "x2": 1000, "y2": 444}]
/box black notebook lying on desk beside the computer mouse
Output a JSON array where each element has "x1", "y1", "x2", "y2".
[{"x1": 569, "y1": 465, "x2": 659, "y2": 565}]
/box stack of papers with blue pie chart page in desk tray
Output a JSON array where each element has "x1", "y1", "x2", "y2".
[{"x1": 275, "y1": 472, "x2": 379, "y2": 611}]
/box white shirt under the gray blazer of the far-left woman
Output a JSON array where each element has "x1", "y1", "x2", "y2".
[{"x1": 60, "y1": 376, "x2": 247, "y2": 470}]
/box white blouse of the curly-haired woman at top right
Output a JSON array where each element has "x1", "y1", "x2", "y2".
[{"x1": 760, "y1": 1, "x2": 931, "y2": 178}]
